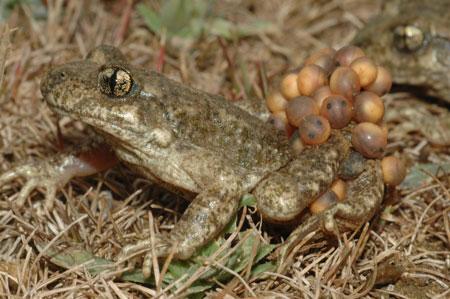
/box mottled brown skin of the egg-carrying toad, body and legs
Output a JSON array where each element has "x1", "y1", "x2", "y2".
[{"x1": 0, "y1": 46, "x2": 383, "y2": 275}]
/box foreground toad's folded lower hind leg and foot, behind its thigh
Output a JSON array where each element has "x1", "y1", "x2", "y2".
[{"x1": 277, "y1": 160, "x2": 384, "y2": 265}]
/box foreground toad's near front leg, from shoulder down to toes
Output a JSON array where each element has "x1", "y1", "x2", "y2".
[{"x1": 117, "y1": 148, "x2": 248, "y2": 277}]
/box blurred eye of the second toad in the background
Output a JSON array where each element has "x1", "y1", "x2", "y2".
[{"x1": 394, "y1": 25, "x2": 425, "y2": 52}]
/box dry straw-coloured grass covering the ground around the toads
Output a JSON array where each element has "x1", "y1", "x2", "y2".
[{"x1": 0, "y1": 0, "x2": 450, "y2": 298}]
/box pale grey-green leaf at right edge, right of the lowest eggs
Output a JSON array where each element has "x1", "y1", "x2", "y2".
[{"x1": 400, "y1": 163, "x2": 450, "y2": 189}]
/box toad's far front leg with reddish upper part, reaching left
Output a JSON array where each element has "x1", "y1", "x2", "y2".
[{"x1": 0, "y1": 147, "x2": 116, "y2": 210}]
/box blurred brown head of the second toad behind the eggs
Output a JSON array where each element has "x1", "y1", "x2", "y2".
[{"x1": 353, "y1": 0, "x2": 450, "y2": 103}]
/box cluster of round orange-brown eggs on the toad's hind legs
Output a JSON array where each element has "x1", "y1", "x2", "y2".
[{"x1": 266, "y1": 46, "x2": 405, "y2": 213}]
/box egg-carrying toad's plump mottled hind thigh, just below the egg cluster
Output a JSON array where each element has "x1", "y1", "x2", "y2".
[{"x1": 252, "y1": 132, "x2": 350, "y2": 222}]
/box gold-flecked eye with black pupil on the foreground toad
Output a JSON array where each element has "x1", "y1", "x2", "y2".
[{"x1": 98, "y1": 66, "x2": 133, "y2": 98}]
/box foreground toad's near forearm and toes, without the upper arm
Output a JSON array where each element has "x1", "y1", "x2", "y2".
[{"x1": 118, "y1": 181, "x2": 244, "y2": 277}]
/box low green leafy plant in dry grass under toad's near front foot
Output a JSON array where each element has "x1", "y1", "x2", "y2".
[{"x1": 36, "y1": 196, "x2": 276, "y2": 298}]
